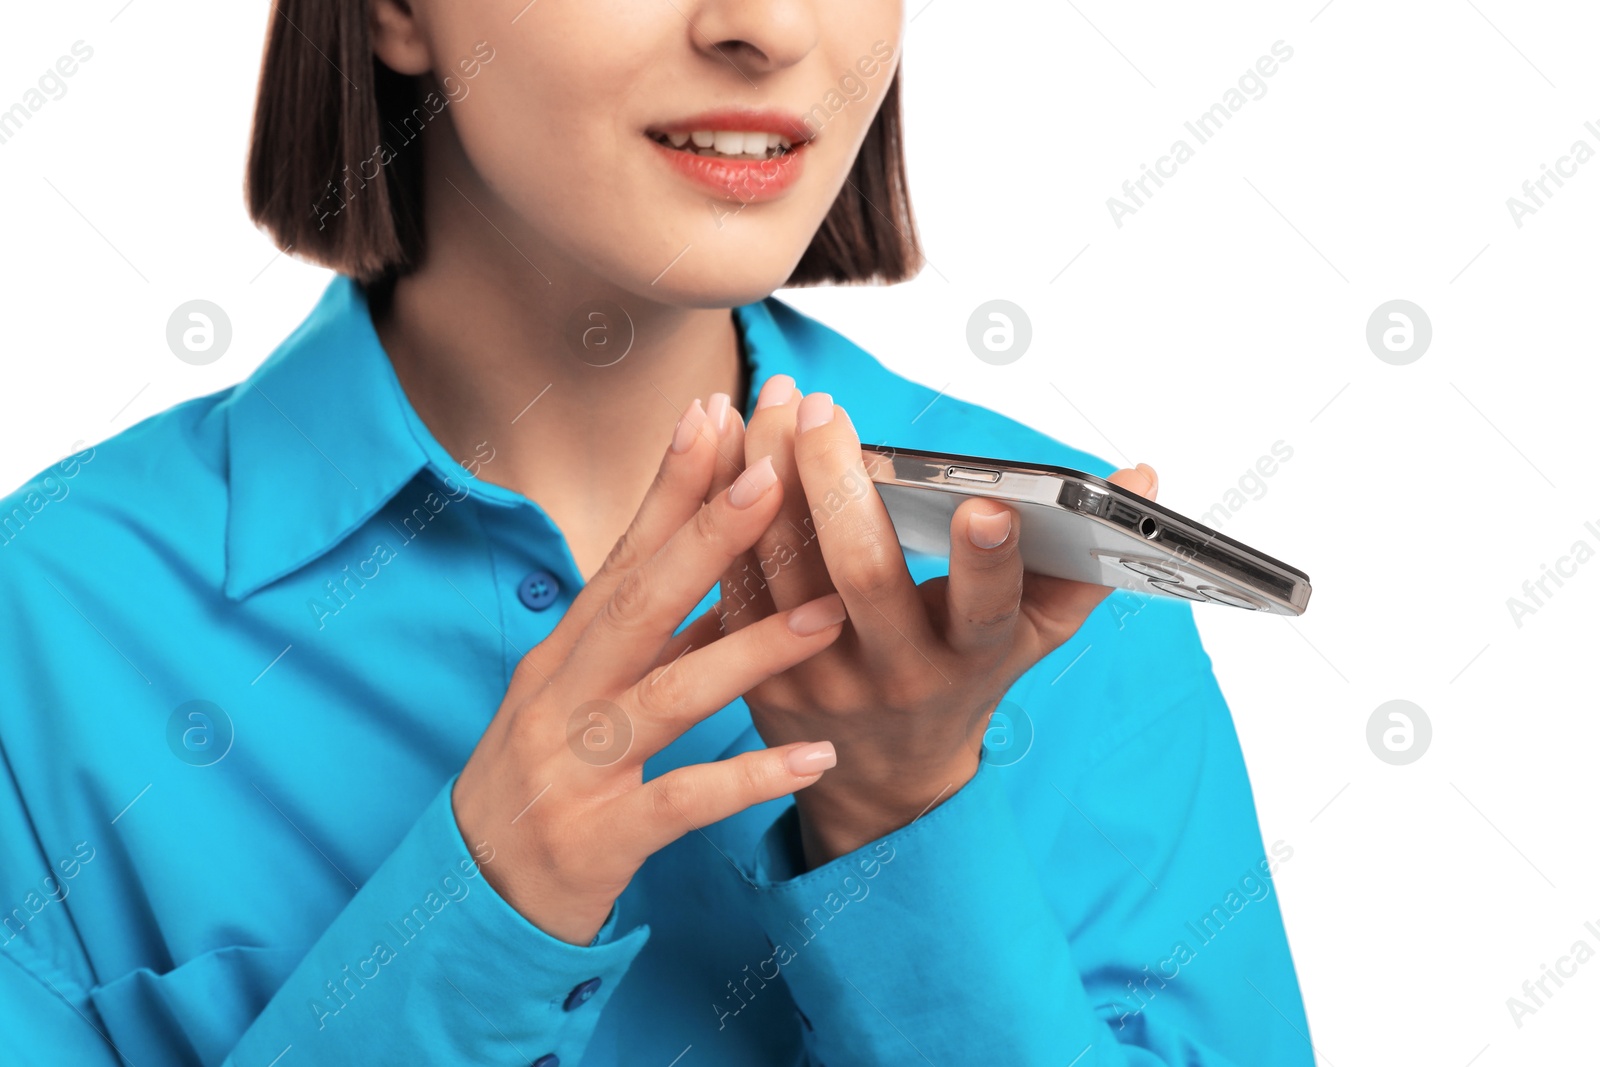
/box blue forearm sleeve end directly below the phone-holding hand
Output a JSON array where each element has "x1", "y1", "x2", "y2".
[{"x1": 730, "y1": 761, "x2": 1094, "y2": 1067}]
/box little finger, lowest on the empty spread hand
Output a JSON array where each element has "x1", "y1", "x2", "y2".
[{"x1": 598, "y1": 741, "x2": 837, "y2": 862}]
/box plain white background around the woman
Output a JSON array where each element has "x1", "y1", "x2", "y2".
[{"x1": 0, "y1": 0, "x2": 1600, "y2": 1067}]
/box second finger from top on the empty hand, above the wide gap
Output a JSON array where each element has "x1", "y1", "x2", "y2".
[{"x1": 563, "y1": 459, "x2": 782, "y2": 685}]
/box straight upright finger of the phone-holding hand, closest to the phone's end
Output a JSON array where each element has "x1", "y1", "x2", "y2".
[{"x1": 795, "y1": 394, "x2": 934, "y2": 662}]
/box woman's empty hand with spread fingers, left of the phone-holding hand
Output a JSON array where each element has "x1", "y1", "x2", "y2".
[{"x1": 451, "y1": 400, "x2": 845, "y2": 945}]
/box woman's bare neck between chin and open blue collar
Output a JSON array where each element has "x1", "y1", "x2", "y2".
[{"x1": 374, "y1": 230, "x2": 742, "y2": 577}]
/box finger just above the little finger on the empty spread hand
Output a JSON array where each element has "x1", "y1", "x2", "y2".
[{"x1": 619, "y1": 593, "x2": 845, "y2": 761}]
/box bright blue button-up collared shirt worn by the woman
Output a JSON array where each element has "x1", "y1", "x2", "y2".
[{"x1": 0, "y1": 277, "x2": 1312, "y2": 1067}]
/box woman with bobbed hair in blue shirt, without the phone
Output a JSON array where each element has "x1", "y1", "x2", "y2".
[{"x1": 0, "y1": 0, "x2": 1310, "y2": 1067}]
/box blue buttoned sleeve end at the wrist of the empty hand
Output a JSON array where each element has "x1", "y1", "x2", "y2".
[{"x1": 230, "y1": 777, "x2": 650, "y2": 1067}]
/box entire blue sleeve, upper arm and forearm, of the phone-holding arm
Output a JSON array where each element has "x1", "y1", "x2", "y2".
[{"x1": 732, "y1": 605, "x2": 1312, "y2": 1067}]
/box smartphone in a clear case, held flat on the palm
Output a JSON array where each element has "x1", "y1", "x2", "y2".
[{"x1": 861, "y1": 445, "x2": 1310, "y2": 616}]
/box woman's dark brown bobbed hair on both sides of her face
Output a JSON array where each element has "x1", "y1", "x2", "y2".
[{"x1": 245, "y1": 0, "x2": 922, "y2": 288}]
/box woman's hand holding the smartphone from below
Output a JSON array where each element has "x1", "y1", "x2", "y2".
[{"x1": 722, "y1": 376, "x2": 1157, "y2": 865}]
